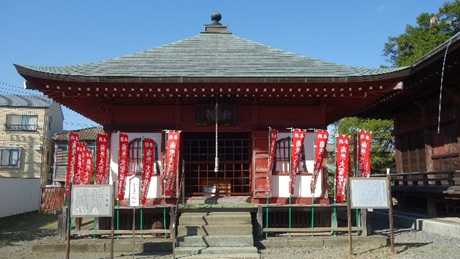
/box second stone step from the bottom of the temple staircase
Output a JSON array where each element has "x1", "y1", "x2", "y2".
[{"x1": 178, "y1": 235, "x2": 254, "y2": 247}]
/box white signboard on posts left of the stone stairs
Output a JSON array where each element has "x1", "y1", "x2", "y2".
[{"x1": 71, "y1": 184, "x2": 113, "y2": 217}]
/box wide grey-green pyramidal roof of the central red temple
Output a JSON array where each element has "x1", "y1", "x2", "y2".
[{"x1": 17, "y1": 33, "x2": 402, "y2": 78}]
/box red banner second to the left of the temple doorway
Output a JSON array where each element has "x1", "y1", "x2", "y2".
[{"x1": 141, "y1": 138, "x2": 155, "y2": 205}]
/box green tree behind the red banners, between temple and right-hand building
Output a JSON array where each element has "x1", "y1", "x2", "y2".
[{"x1": 336, "y1": 117, "x2": 394, "y2": 173}]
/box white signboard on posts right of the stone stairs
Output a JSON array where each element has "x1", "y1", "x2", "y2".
[{"x1": 350, "y1": 177, "x2": 390, "y2": 209}]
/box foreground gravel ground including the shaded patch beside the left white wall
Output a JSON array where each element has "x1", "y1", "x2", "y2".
[{"x1": 0, "y1": 215, "x2": 460, "y2": 259}]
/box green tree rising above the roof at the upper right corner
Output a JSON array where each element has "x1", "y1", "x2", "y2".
[{"x1": 384, "y1": 0, "x2": 460, "y2": 66}]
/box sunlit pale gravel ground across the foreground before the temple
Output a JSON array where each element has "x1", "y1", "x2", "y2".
[{"x1": 0, "y1": 230, "x2": 460, "y2": 259}]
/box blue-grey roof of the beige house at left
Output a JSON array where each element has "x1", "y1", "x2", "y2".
[{"x1": 0, "y1": 95, "x2": 52, "y2": 108}]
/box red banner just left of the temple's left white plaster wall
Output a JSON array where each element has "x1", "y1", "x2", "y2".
[{"x1": 96, "y1": 133, "x2": 109, "y2": 184}]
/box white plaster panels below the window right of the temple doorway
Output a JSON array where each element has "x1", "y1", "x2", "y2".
[{"x1": 271, "y1": 173, "x2": 323, "y2": 198}]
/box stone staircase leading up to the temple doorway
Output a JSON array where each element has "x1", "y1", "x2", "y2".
[{"x1": 176, "y1": 212, "x2": 260, "y2": 259}]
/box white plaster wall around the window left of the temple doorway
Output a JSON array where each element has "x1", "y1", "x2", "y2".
[{"x1": 109, "y1": 132, "x2": 162, "y2": 199}]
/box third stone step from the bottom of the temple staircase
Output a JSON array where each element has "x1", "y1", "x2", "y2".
[{"x1": 177, "y1": 224, "x2": 252, "y2": 237}]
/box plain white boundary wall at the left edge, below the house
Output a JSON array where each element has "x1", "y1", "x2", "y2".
[{"x1": 0, "y1": 178, "x2": 41, "y2": 218}]
